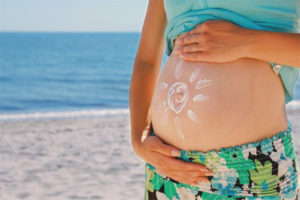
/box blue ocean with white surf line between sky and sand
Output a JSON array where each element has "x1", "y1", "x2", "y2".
[{"x1": 0, "y1": 32, "x2": 300, "y2": 120}]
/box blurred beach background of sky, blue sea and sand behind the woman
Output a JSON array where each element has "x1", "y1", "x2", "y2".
[{"x1": 0, "y1": 0, "x2": 300, "y2": 200}]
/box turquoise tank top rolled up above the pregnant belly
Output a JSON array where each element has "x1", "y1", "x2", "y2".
[{"x1": 164, "y1": 0, "x2": 300, "y2": 104}]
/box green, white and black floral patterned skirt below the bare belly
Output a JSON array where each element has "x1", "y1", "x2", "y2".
[{"x1": 144, "y1": 121, "x2": 299, "y2": 200}]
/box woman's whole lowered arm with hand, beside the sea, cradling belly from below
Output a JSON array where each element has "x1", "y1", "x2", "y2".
[{"x1": 129, "y1": 0, "x2": 212, "y2": 185}]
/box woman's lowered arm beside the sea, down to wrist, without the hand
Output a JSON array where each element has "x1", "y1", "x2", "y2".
[{"x1": 129, "y1": 0, "x2": 167, "y2": 153}]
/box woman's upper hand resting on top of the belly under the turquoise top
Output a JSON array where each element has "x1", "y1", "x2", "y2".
[{"x1": 174, "y1": 20, "x2": 255, "y2": 62}]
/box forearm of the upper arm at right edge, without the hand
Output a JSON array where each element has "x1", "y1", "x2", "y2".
[{"x1": 245, "y1": 29, "x2": 300, "y2": 68}]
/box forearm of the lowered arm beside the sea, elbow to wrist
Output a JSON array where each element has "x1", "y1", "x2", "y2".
[{"x1": 129, "y1": 59, "x2": 160, "y2": 153}]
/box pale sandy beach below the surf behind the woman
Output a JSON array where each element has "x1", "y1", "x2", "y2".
[{"x1": 0, "y1": 105, "x2": 300, "y2": 200}]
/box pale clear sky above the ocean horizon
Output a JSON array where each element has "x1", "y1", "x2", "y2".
[{"x1": 0, "y1": 0, "x2": 148, "y2": 32}]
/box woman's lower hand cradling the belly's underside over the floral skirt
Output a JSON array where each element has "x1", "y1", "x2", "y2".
[{"x1": 138, "y1": 136, "x2": 213, "y2": 185}]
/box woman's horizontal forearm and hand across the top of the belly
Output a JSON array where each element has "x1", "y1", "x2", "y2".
[{"x1": 174, "y1": 20, "x2": 300, "y2": 68}]
